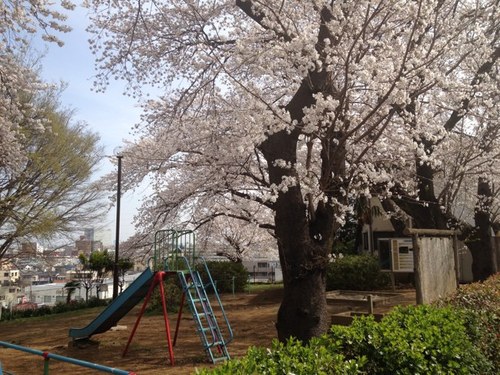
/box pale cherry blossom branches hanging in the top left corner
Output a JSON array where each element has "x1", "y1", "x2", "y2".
[{"x1": 0, "y1": 0, "x2": 74, "y2": 173}]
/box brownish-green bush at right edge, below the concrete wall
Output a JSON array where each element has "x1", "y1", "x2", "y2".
[{"x1": 436, "y1": 273, "x2": 500, "y2": 374}]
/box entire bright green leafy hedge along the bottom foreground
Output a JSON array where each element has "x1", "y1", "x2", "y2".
[{"x1": 197, "y1": 289, "x2": 499, "y2": 375}]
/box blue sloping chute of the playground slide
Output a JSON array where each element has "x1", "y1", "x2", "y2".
[{"x1": 69, "y1": 267, "x2": 154, "y2": 340}]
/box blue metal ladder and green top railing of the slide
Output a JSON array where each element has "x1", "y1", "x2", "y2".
[{"x1": 154, "y1": 230, "x2": 233, "y2": 363}]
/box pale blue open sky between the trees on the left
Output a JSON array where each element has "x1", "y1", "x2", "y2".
[{"x1": 35, "y1": 7, "x2": 141, "y2": 244}]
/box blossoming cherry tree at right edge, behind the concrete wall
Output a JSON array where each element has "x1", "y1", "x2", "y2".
[{"x1": 378, "y1": 2, "x2": 500, "y2": 280}]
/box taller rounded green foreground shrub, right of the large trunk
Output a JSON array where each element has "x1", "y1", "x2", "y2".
[{"x1": 331, "y1": 306, "x2": 494, "y2": 375}]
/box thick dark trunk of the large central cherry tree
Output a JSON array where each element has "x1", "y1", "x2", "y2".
[{"x1": 260, "y1": 130, "x2": 333, "y2": 342}]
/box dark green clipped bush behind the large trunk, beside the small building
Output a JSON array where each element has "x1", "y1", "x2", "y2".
[{"x1": 326, "y1": 255, "x2": 390, "y2": 290}]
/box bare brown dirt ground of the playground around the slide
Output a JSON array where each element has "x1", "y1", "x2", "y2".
[{"x1": 0, "y1": 289, "x2": 414, "y2": 375}]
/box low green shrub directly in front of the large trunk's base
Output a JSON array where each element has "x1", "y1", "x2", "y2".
[{"x1": 197, "y1": 338, "x2": 359, "y2": 375}]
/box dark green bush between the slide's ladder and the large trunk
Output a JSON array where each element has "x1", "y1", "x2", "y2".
[{"x1": 197, "y1": 262, "x2": 248, "y2": 293}]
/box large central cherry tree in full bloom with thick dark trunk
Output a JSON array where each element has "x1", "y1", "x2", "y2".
[{"x1": 89, "y1": 0, "x2": 498, "y2": 341}]
